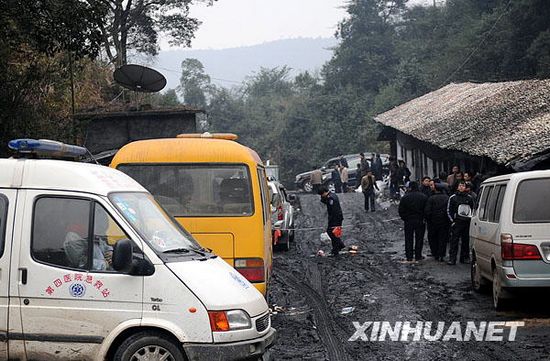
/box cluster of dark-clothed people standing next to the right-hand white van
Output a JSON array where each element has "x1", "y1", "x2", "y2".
[{"x1": 396, "y1": 165, "x2": 481, "y2": 265}]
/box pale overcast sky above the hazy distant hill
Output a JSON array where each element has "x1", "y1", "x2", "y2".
[{"x1": 161, "y1": 0, "x2": 441, "y2": 50}]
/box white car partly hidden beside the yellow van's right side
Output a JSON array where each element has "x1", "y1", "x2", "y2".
[{"x1": 268, "y1": 181, "x2": 294, "y2": 251}]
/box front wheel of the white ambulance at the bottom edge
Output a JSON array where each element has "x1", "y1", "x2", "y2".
[{"x1": 114, "y1": 331, "x2": 185, "y2": 361}]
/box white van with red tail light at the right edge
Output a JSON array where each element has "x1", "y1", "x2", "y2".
[{"x1": 470, "y1": 171, "x2": 550, "y2": 309}]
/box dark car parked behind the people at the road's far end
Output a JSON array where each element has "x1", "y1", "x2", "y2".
[{"x1": 294, "y1": 152, "x2": 390, "y2": 192}]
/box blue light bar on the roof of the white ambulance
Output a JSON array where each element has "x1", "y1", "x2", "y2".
[{"x1": 8, "y1": 139, "x2": 87, "y2": 158}]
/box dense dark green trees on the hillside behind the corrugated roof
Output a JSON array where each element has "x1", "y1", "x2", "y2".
[{"x1": 208, "y1": 0, "x2": 550, "y2": 184}]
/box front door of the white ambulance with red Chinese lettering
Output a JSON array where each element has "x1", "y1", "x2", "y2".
[{"x1": 19, "y1": 190, "x2": 143, "y2": 361}]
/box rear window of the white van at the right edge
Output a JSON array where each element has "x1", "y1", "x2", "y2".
[{"x1": 514, "y1": 178, "x2": 550, "y2": 223}]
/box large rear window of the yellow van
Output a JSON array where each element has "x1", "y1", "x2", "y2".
[{"x1": 117, "y1": 164, "x2": 254, "y2": 217}]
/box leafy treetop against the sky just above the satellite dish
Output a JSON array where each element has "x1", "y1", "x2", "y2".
[{"x1": 90, "y1": 0, "x2": 216, "y2": 66}]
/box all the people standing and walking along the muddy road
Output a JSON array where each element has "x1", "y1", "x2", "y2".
[{"x1": 311, "y1": 153, "x2": 482, "y2": 265}]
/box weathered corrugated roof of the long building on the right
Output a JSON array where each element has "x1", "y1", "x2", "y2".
[{"x1": 374, "y1": 80, "x2": 550, "y2": 164}]
